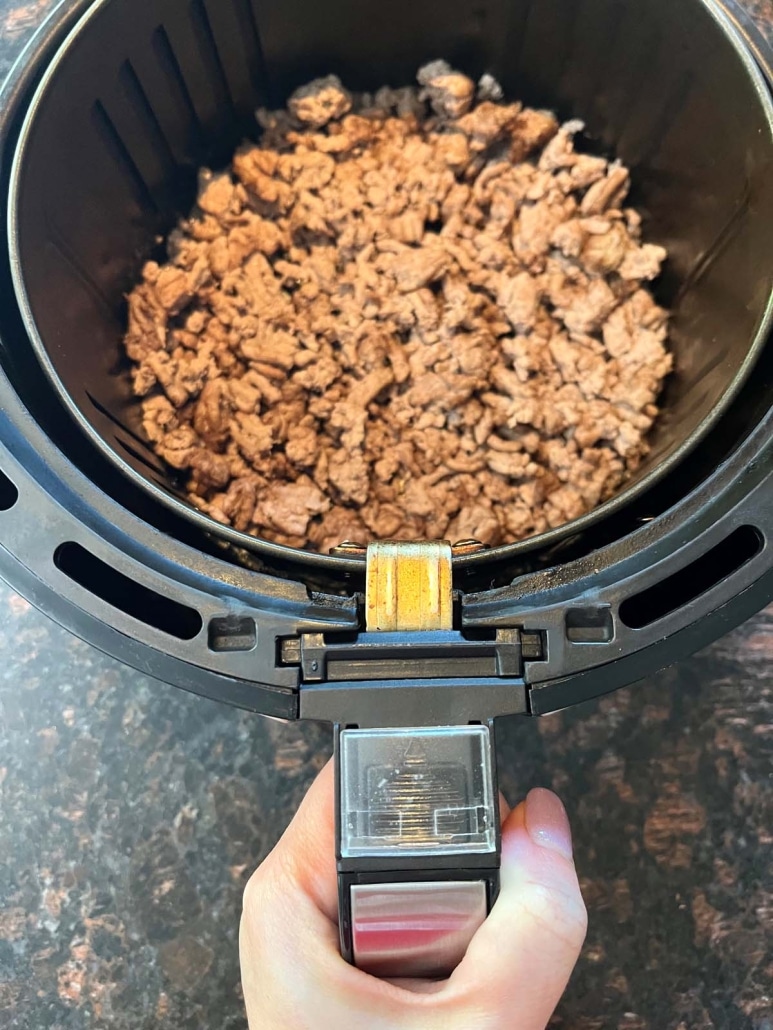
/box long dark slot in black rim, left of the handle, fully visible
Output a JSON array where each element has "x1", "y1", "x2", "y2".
[{"x1": 54, "y1": 542, "x2": 203, "y2": 641}]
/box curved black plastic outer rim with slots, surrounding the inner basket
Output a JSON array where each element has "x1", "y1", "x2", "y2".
[{"x1": 0, "y1": 0, "x2": 773, "y2": 724}]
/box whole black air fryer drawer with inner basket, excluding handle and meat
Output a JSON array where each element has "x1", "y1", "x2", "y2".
[{"x1": 0, "y1": 0, "x2": 773, "y2": 972}]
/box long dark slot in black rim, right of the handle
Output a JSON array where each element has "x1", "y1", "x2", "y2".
[{"x1": 619, "y1": 525, "x2": 765, "y2": 629}]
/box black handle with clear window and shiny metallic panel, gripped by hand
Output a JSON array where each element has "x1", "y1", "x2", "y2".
[{"x1": 336, "y1": 725, "x2": 500, "y2": 976}]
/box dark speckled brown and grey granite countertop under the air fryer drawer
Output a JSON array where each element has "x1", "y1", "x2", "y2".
[{"x1": 0, "y1": 0, "x2": 773, "y2": 1030}]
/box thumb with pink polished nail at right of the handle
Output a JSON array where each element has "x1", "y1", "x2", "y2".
[{"x1": 451, "y1": 789, "x2": 587, "y2": 1030}]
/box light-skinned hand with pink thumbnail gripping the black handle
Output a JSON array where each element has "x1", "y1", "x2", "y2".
[{"x1": 239, "y1": 762, "x2": 586, "y2": 1030}]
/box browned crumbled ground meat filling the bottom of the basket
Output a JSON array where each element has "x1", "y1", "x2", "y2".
[{"x1": 126, "y1": 62, "x2": 671, "y2": 550}]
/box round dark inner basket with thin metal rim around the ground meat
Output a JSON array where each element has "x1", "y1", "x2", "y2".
[{"x1": 11, "y1": 0, "x2": 773, "y2": 576}]
